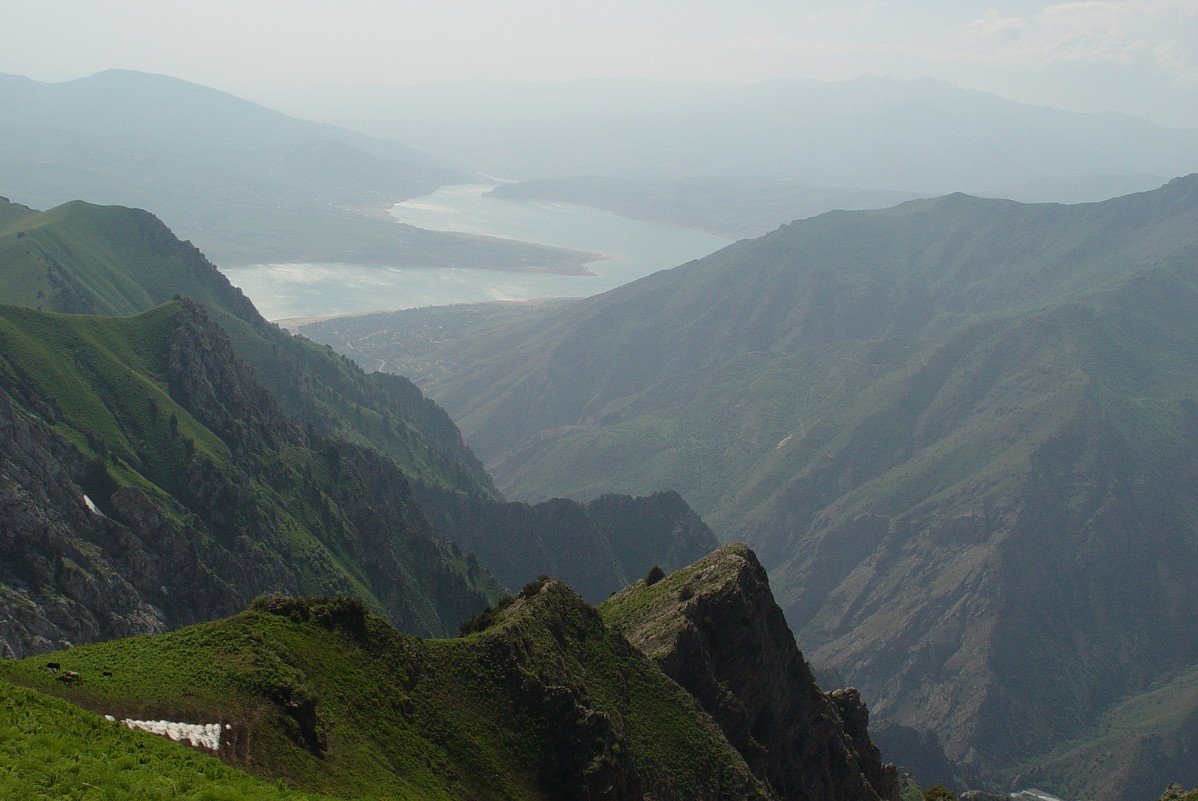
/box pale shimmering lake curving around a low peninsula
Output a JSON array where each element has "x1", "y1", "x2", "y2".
[{"x1": 222, "y1": 184, "x2": 730, "y2": 320}]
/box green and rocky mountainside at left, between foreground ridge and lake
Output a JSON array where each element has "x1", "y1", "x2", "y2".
[{"x1": 0, "y1": 191, "x2": 715, "y2": 656}]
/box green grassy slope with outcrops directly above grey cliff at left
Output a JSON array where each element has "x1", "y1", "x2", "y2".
[{"x1": 0, "y1": 302, "x2": 497, "y2": 632}]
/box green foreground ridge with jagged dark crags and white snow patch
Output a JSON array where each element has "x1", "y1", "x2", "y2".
[{"x1": 0, "y1": 536, "x2": 899, "y2": 801}]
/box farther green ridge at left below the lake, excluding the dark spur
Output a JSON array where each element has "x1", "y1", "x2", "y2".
[{"x1": 0, "y1": 201, "x2": 491, "y2": 493}]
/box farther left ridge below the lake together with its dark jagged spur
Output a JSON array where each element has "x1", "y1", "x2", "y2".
[{"x1": 0, "y1": 191, "x2": 716, "y2": 623}]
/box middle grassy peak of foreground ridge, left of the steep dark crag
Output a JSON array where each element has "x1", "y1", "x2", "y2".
[{"x1": 464, "y1": 576, "x2": 778, "y2": 801}]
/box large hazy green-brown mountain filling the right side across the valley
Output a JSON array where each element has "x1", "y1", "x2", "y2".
[{"x1": 301, "y1": 176, "x2": 1198, "y2": 797}]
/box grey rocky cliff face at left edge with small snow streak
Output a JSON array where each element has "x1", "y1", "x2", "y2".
[{"x1": 0, "y1": 387, "x2": 246, "y2": 659}]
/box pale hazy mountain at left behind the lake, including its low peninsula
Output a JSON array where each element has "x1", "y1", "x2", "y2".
[{"x1": 0, "y1": 69, "x2": 586, "y2": 269}]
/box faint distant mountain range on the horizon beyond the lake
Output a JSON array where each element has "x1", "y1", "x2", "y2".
[{"x1": 264, "y1": 77, "x2": 1198, "y2": 198}]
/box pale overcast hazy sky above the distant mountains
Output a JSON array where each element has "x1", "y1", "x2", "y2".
[{"x1": 7, "y1": 0, "x2": 1198, "y2": 126}]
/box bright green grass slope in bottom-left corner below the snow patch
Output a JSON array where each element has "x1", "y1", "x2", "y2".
[{"x1": 0, "y1": 681, "x2": 332, "y2": 801}]
